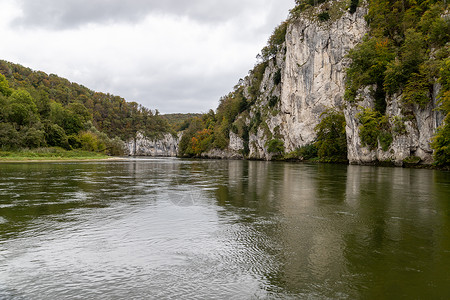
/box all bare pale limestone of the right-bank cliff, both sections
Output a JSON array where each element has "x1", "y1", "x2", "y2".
[{"x1": 214, "y1": 1, "x2": 443, "y2": 165}]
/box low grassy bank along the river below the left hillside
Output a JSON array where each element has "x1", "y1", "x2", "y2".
[{"x1": 0, "y1": 147, "x2": 110, "y2": 162}]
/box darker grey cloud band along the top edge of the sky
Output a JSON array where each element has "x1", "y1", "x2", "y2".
[{"x1": 14, "y1": 0, "x2": 282, "y2": 29}]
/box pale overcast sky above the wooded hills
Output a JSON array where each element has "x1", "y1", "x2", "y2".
[{"x1": 0, "y1": 0, "x2": 294, "y2": 113}]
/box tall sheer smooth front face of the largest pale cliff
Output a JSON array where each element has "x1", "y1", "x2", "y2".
[{"x1": 281, "y1": 8, "x2": 368, "y2": 151}]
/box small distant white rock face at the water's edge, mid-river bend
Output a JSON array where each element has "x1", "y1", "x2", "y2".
[{"x1": 126, "y1": 132, "x2": 181, "y2": 157}]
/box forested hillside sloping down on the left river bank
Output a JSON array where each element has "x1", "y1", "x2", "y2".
[{"x1": 0, "y1": 61, "x2": 172, "y2": 155}]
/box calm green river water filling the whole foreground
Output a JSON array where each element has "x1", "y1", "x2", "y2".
[{"x1": 0, "y1": 159, "x2": 450, "y2": 299}]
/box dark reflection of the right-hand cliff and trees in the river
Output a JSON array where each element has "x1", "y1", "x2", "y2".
[{"x1": 216, "y1": 161, "x2": 449, "y2": 298}]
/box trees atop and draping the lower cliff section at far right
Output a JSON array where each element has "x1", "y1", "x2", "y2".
[{"x1": 345, "y1": 0, "x2": 450, "y2": 165}]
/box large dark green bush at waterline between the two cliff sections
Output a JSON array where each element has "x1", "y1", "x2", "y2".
[{"x1": 314, "y1": 109, "x2": 347, "y2": 162}]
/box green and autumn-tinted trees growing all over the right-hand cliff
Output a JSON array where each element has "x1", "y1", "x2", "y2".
[{"x1": 180, "y1": 0, "x2": 450, "y2": 165}]
